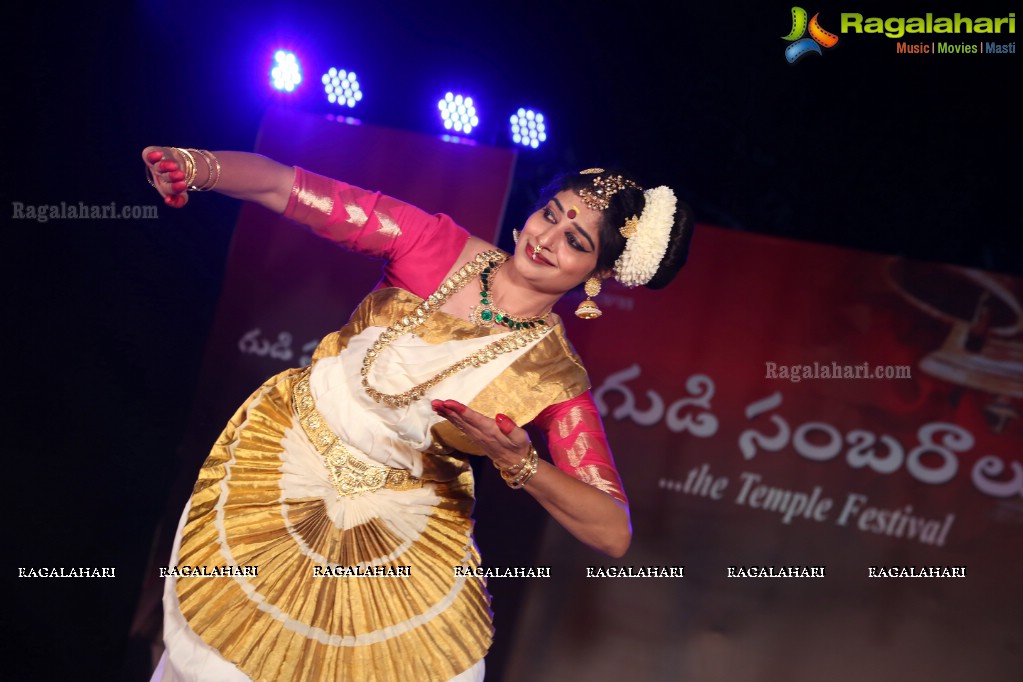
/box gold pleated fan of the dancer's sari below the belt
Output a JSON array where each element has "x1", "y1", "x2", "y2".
[{"x1": 177, "y1": 370, "x2": 492, "y2": 682}]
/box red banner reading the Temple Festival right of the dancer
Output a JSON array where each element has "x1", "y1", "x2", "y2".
[{"x1": 504, "y1": 228, "x2": 1023, "y2": 682}]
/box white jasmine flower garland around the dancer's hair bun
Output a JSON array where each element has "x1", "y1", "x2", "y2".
[{"x1": 615, "y1": 185, "x2": 676, "y2": 287}]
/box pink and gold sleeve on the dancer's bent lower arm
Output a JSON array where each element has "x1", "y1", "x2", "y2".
[{"x1": 533, "y1": 391, "x2": 628, "y2": 504}]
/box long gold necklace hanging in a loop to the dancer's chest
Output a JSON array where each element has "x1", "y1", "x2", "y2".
[{"x1": 361, "y1": 251, "x2": 550, "y2": 407}]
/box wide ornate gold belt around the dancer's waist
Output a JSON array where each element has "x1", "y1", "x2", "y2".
[{"x1": 292, "y1": 367, "x2": 422, "y2": 497}]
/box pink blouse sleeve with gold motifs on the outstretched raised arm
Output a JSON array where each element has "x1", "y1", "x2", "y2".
[{"x1": 284, "y1": 168, "x2": 469, "y2": 297}]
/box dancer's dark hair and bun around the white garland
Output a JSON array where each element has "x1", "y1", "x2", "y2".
[{"x1": 540, "y1": 170, "x2": 695, "y2": 289}]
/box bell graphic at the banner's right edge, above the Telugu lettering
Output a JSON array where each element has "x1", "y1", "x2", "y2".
[{"x1": 889, "y1": 262, "x2": 1023, "y2": 433}]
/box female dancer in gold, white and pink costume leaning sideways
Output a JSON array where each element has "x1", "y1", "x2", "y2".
[{"x1": 142, "y1": 147, "x2": 693, "y2": 682}]
